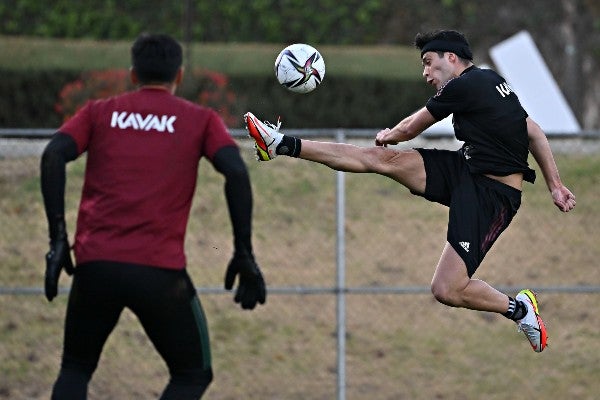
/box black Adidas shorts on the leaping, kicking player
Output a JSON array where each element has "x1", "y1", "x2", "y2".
[{"x1": 413, "y1": 149, "x2": 521, "y2": 277}]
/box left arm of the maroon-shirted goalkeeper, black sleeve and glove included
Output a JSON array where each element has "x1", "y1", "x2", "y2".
[{"x1": 40, "y1": 132, "x2": 78, "y2": 301}]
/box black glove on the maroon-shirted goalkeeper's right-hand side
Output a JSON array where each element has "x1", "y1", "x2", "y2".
[{"x1": 225, "y1": 255, "x2": 267, "y2": 310}]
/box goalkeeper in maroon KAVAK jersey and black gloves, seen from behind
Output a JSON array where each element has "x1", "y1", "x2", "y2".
[{"x1": 41, "y1": 34, "x2": 266, "y2": 400}]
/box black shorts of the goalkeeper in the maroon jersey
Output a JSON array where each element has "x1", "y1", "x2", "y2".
[{"x1": 63, "y1": 261, "x2": 211, "y2": 374}]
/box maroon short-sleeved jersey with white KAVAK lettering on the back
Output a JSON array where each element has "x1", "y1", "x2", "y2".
[{"x1": 59, "y1": 88, "x2": 236, "y2": 269}]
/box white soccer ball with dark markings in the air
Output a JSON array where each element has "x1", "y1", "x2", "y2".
[{"x1": 275, "y1": 43, "x2": 325, "y2": 93}]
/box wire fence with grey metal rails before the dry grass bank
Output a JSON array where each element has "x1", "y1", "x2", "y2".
[{"x1": 0, "y1": 130, "x2": 600, "y2": 399}]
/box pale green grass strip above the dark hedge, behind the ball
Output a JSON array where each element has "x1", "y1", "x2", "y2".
[{"x1": 0, "y1": 36, "x2": 421, "y2": 80}]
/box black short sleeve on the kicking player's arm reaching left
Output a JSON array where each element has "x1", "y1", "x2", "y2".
[{"x1": 425, "y1": 78, "x2": 469, "y2": 121}]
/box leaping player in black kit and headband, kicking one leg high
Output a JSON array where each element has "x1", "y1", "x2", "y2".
[{"x1": 245, "y1": 30, "x2": 575, "y2": 352}]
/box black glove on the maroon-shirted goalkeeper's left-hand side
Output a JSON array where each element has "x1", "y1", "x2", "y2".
[{"x1": 44, "y1": 222, "x2": 75, "y2": 301}]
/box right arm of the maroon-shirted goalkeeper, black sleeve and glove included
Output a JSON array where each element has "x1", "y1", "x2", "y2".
[{"x1": 212, "y1": 146, "x2": 267, "y2": 310}]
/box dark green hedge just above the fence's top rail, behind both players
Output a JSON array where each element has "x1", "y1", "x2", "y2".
[{"x1": 0, "y1": 70, "x2": 432, "y2": 128}]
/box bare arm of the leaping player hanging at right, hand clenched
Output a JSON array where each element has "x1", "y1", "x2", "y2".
[{"x1": 527, "y1": 117, "x2": 576, "y2": 212}]
